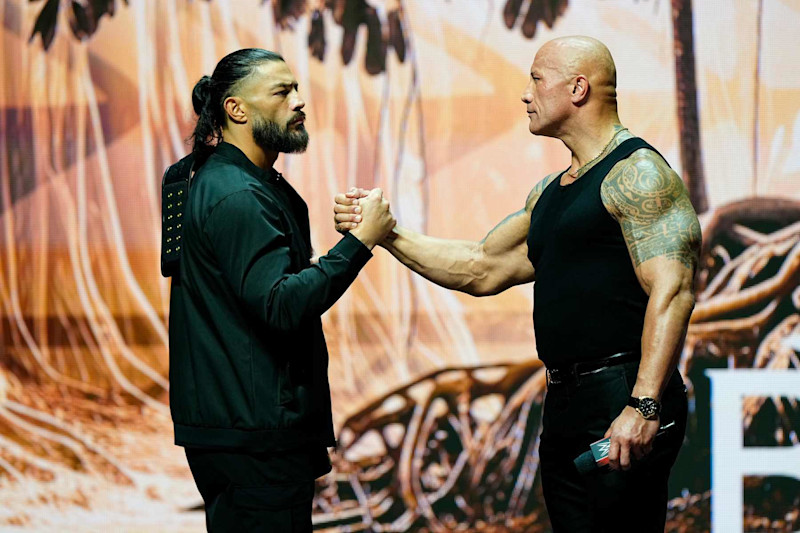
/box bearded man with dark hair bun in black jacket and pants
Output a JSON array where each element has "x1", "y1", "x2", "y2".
[{"x1": 169, "y1": 49, "x2": 395, "y2": 533}]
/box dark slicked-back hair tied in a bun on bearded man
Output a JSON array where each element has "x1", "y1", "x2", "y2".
[{"x1": 189, "y1": 48, "x2": 283, "y2": 166}]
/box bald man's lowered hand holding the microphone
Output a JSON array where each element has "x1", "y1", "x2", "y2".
[{"x1": 604, "y1": 407, "x2": 659, "y2": 470}]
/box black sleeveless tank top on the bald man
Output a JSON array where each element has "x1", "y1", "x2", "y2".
[{"x1": 528, "y1": 138, "x2": 660, "y2": 367}]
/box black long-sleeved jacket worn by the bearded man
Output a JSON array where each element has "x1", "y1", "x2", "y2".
[{"x1": 169, "y1": 143, "x2": 372, "y2": 451}]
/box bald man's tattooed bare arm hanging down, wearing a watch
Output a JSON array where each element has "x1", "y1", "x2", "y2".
[{"x1": 601, "y1": 150, "x2": 701, "y2": 468}]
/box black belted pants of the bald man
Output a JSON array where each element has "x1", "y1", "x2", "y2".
[{"x1": 539, "y1": 362, "x2": 687, "y2": 533}]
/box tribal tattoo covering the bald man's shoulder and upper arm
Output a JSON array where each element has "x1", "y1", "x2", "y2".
[{"x1": 600, "y1": 151, "x2": 701, "y2": 270}]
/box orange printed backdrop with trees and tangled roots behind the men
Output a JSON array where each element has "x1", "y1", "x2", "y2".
[{"x1": 0, "y1": 0, "x2": 800, "y2": 533}]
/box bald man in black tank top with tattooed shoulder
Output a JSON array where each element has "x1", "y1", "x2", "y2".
[{"x1": 335, "y1": 37, "x2": 700, "y2": 533}]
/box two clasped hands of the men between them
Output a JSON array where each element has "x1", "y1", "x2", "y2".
[{"x1": 333, "y1": 188, "x2": 397, "y2": 250}]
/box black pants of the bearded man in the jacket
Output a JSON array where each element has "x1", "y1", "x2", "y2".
[{"x1": 186, "y1": 448, "x2": 331, "y2": 533}]
